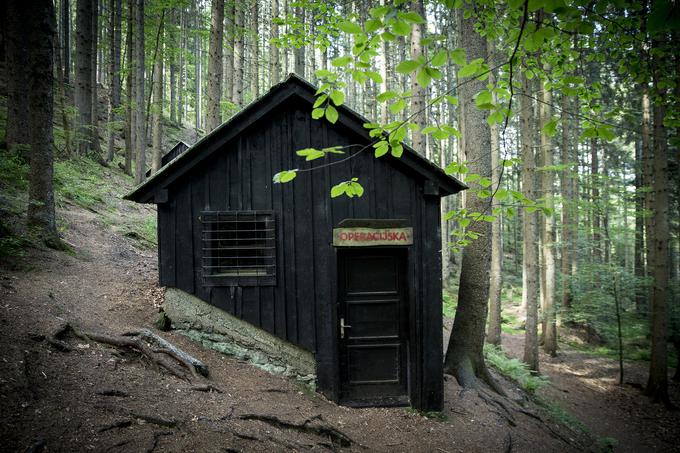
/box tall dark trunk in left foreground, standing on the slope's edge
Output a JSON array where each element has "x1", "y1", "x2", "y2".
[{"x1": 24, "y1": 0, "x2": 58, "y2": 240}]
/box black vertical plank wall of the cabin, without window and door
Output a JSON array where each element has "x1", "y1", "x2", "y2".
[{"x1": 158, "y1": 99, "x2": 442, "y2": 409}]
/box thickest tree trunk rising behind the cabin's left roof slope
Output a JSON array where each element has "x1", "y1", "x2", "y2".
[{"x1": 206, "y1": 0, "x2": 224, "y2": 133}]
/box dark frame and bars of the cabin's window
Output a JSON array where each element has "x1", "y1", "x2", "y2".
[{"x1": 199, "y1": 210, "x2": 278, "y2": 286}]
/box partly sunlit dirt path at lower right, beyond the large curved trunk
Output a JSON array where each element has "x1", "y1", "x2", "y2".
[{"x1": 502, "y1": 333, "x2": 680, "y2": 452}]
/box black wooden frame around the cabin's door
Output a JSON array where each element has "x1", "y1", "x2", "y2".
[{"x1": 332, "y1": 246, "x2": 416, "y2": 407}]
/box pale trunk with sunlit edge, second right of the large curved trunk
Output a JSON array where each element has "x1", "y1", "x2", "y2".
[{"x1": 520, "y1": 73, "x2": 538, "y2": 372}]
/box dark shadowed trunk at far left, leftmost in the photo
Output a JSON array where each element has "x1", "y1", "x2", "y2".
[{"x1": 5, "y1": 0, "x2": 31, "y2": 160}]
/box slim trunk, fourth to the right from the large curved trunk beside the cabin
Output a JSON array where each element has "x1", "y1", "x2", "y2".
[{"x1": 560, "y1": 94, "x2": 578, "y2": 310}]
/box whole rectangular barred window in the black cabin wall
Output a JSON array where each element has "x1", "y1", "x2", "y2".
[{"x1": 201, "y1": 211, "x2": 276, "y2": 286}]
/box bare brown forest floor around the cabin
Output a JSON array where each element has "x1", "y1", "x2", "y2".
[{"x1": 0, "y1": 163, "x2": 680, "y2": 452}]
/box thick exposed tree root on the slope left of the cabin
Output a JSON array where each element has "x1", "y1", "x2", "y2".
[{"x1": 46, "y1": 323, "x2": 208, "y2": 381}]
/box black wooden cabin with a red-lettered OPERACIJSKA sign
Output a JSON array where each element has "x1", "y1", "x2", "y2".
[{"x1": 126, "y1": 75, "x2": 465, "y2": 410}]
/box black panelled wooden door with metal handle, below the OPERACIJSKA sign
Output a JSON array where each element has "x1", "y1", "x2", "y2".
[{"x1": 338, "y1": 248, "x2": 409, "y2": 406}]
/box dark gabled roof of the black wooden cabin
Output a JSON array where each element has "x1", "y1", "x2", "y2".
[{"x1": 124, "y1": 74, "x2": 467, "y2": 203}]
